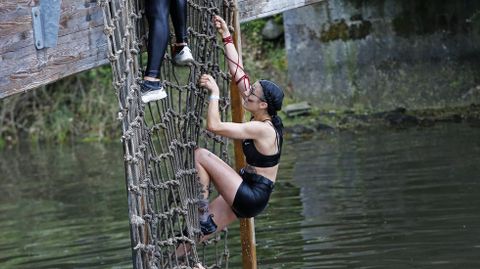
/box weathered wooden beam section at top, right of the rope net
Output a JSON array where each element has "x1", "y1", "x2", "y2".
[{"x1": 238, "y1": 0, "x2": 325, "y2": 22}]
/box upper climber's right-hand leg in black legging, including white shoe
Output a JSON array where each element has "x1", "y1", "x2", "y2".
[{"x1": 170, "y1": 0, "x2": 193, "y2": 65}]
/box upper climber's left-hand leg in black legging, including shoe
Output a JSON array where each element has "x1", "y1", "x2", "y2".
[{"x1": 141, "y1": 0, "x2": 170, "y2": 103}]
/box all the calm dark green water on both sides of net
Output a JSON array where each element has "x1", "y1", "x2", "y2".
[{"x1": 0, "y1": 124, "x2": 480, "y2": 269}]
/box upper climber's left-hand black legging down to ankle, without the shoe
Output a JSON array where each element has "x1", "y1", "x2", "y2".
[{"x1": 145, "y1": 0, "x2": 170, "y2": 80}]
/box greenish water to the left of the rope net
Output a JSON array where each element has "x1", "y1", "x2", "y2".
[{"x1": 0, "y1": 145, "x2": 131, "y2": 268}]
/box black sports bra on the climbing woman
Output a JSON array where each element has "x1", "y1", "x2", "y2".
[{"x1": 242, "y1": 120, "x2": 283, "y2": 167}]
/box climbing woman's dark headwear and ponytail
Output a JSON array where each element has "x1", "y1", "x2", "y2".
[{"x1": 259, "y1": 80, "x2": 284, "y2": 135}]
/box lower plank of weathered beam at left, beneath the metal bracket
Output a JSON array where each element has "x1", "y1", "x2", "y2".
[{"x1": 0, "y1": 25, "x2": 108, "y2": 98}]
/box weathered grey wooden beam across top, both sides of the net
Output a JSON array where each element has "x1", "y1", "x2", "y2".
[{"x1": 0, "y1": 0, "x2": 323, "y2": 99}]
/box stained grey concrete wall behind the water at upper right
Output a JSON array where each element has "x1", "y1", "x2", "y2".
[{"x1": 284, "y1": 0, "x2": 480, "y2": 111}]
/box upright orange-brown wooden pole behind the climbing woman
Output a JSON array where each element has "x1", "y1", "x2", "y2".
[{"x1": 230, "y1": 1, "x2": 257, "y2": 269}]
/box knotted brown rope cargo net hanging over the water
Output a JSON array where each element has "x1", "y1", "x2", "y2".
[{"x1": 98, "y1": 0, "x2": 235, "y2": 268}]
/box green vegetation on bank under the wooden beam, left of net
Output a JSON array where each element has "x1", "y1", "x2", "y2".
[{"x1": 0, "y1": 66, "x2": 120, "y2": 147}]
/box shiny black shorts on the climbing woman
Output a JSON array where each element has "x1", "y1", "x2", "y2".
[{"x1": 232, "y1": 169, "x2": 274, "y2": 218}]
